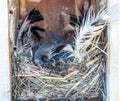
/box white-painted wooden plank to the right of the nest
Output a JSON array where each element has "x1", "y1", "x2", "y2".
[{"x1": 107, "y1": 0, "x2": 120, "y2": 101}]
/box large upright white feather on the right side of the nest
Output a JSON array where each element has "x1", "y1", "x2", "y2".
[{"x1": 75, "y1": 6, "x2": 106, "y2": 56}]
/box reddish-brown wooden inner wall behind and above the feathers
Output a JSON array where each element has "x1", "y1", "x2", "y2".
[{"x1": 9, "y1": 0, "x2": 107, "y2": 101}]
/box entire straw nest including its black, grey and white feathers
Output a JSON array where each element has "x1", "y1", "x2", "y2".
[{"x1": 12, "y1": 6, "x2": 107, "y2": 101}]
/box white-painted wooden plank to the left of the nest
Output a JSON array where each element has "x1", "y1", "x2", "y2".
[{"x1": 0, "y1": 0, "x2": 11, "y2": 101}]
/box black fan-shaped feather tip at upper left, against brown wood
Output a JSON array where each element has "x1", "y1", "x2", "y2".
[{"x1": 27, "y1": 8, "x2": 44, "y2": 23}]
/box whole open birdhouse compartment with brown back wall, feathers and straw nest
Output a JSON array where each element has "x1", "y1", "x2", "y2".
[{"x1": 9, "y1": 0, "x2": 107, "y2": 101}]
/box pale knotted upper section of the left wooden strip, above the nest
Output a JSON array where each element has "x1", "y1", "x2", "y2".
[{"x1": 8, "y1": 0, "x2": 19, "y2": 45}]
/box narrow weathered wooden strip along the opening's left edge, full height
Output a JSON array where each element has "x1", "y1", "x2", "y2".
[{"x1": 8, "y1": 0, "x2": 19, "y2": 100}]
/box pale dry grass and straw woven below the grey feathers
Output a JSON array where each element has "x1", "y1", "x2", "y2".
[{"x1": 12, "y1": 31, "x2": 107, "y2": 99}]
